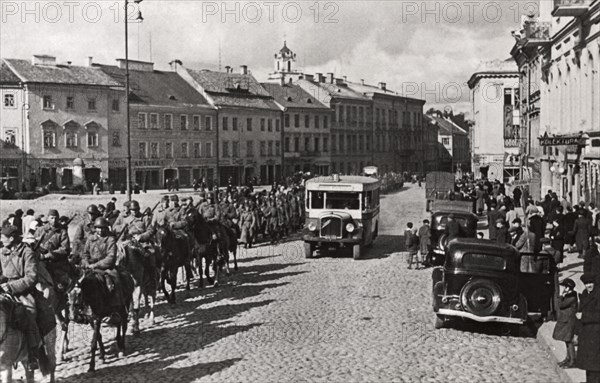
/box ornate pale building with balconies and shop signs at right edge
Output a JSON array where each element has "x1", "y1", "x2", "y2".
[{"x1": 511, "y1": 0, "x2": 600, "y2": 203}]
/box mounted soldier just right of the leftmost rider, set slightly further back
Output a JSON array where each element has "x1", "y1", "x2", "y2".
[{"x1": 35, "y1": 209, "x2": 72, "y2": 291}]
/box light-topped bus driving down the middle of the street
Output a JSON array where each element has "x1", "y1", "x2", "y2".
[{"x1": 302, "y1": 174, "x2": 380, "y2": 259}]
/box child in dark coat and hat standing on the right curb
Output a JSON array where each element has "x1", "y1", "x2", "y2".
[{"x1": 552, "y1": 278, "x2": 577, "y2": 368}]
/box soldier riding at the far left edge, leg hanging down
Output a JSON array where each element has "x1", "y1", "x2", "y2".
[{"x1": 0, "y1": 226, "x2": 42, "y2": 370}]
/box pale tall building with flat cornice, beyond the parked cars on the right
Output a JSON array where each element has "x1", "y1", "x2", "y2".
[{"x1": 468, "y1": 59, "x2": 526, "y2": 182}]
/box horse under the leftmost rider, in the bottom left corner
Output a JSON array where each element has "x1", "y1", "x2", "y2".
[{"x1": 0, "y1": 293, "x2": 56, "y2": 383}]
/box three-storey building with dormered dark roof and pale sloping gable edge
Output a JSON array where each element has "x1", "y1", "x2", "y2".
[{"x1": 175, "y1": 63, "x2": 282, "y2": 184}]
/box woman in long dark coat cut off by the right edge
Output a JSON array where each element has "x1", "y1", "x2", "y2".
[{"x1": 576, "y1": 273, "x2": 600, "y2": 383}]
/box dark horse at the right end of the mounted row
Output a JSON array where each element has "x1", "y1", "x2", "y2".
[{"x1": 185, "y1": 209, "x2": 224, "y2": 287}]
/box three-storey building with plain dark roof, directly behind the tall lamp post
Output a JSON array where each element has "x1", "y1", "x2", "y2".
[{"x1": 95, "y1": 59, "x2": 217, "y2": 189}]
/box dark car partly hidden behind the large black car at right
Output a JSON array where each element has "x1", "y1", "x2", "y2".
[{"x1": 429, "y1": 210, "x2": 478, "y2": 266}]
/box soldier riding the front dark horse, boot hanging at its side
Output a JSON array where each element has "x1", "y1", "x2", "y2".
[{"x1": 81, "y1": 217, "x2": 124, "y2": 325}]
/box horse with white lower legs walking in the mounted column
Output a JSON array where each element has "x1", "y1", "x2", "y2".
[{"x1": 117, "y1": 241, "x2": 160, "y2": 335}]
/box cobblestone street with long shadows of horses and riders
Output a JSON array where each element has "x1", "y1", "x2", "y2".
[{"x1": 19, "y1": 185, "x2": 558, "y2": 382}]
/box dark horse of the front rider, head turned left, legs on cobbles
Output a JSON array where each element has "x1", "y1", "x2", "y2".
[{"x1": 67, "y1": 269, "x2": 134, "y2": 372}]
